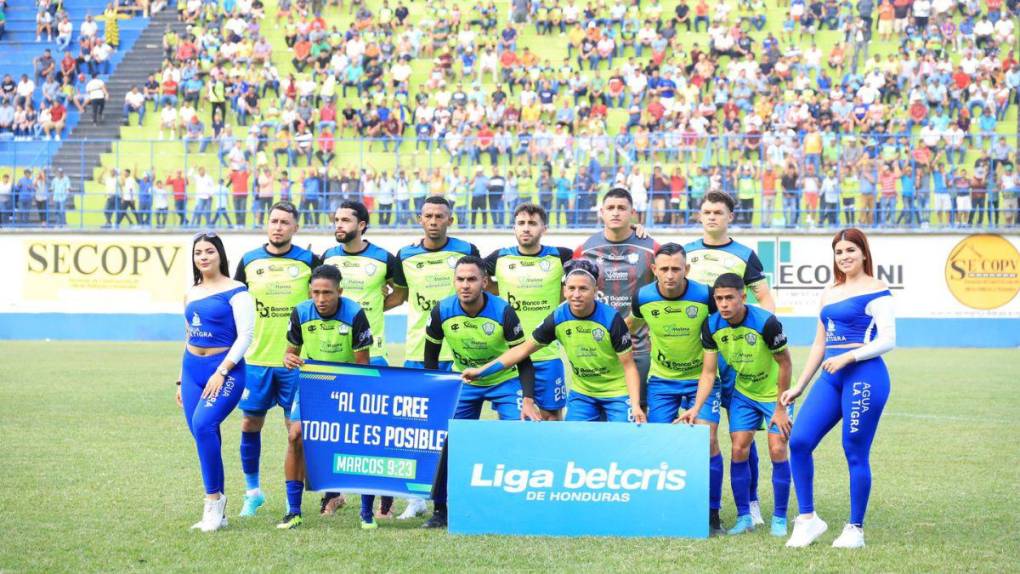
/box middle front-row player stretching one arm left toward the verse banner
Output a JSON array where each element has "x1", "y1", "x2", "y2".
[{"x1": 463, "y1": 260, "x2": 647, "y2": 423}]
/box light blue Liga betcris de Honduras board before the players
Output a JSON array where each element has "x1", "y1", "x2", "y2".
[{"x1": 449, "y1": 420, "x2": 709, "y2": 538}]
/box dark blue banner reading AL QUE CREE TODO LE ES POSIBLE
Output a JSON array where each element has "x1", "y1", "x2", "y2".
[{"x1": 299, "y1": 361, "x2": 461, "y2": 498}]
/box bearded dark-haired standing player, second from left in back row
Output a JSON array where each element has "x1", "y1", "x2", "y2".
[{"x1": 321, "y1": 201, "x2": 412, "y2": 519}]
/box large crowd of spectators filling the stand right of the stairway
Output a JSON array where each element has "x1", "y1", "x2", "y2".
[{"x1": 5, "y1": 0, "x2": 1020, "y2": 226}]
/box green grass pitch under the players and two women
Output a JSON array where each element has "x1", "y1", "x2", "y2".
[{"x1": 0, "y1": 342, "x2": 1020, "y2": 573}]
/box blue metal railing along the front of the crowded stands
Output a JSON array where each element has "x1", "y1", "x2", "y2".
[{"x1": 0, "y1": 133, "x2": 1020, "y2": 228}]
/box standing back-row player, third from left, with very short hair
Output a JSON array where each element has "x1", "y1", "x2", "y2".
[{"x1": 394, "y1": 196, "x2": 478, "y2": 371}]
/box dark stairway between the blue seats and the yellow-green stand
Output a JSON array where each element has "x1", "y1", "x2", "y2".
[{"x1": 52, "y1": 8, "x2": 185, "y2": 190}]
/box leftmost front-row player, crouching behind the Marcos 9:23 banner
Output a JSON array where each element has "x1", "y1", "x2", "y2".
[{"x1": 284, "y1": 265, "x2": 376, "y2": 529}]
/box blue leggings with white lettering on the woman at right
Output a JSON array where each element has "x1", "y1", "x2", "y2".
[{"x1": 789, "y1": 349, "x2": 889, "y2": 526}]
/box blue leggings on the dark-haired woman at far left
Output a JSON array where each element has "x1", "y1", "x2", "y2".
[{"x1": 181, "y1": 351, "x2": 245, "y2": 494}]
